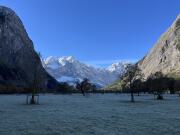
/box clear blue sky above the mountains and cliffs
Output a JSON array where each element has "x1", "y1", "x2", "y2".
[{"x1": 0, "y1": 0, "x2": 180, "y2": 66}]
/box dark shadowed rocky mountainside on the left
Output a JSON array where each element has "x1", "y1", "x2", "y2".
[{"x1": 0, "y1": 6, "x2": 56, "y2": 88}]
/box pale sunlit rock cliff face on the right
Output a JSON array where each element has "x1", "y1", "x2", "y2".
[{"x1": 138, "y1": 16, "x2": 180, "y2": 79}]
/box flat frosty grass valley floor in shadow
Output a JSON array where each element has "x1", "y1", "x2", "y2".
[{"x1": 0, "y1": 94, "x2": 180, "y2": 135}]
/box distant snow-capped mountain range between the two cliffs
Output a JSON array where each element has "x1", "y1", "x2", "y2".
[{"x1": 42, "y1": 56, "x2": 127, "y2": 87}]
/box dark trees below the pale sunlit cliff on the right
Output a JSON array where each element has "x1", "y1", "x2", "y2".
[{"x1": 121, "y1": 65, "x2": 180, "y2": 102}]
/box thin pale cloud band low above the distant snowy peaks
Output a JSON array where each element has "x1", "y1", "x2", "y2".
[{"x1": 85, "y1": 59, "x2": 138, "y2": 68}]
